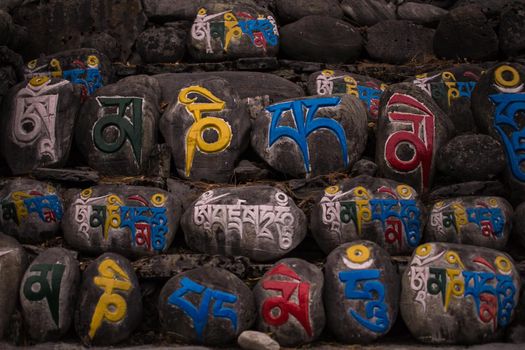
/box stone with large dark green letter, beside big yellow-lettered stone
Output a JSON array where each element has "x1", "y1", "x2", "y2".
[{"x1": 75, "y1": 75, "x2": 161, "y2": 175}]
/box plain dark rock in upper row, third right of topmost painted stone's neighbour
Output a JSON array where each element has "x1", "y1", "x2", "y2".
[{"x1": 365, "y1": 20, "x2": 435, "y2": 64}]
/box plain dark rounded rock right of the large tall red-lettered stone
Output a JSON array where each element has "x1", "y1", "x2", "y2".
[{"x1": 437, "y1": 134, "x2": 506, "y2": 182}]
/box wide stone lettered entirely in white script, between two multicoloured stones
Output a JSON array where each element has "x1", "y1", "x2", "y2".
[{"x1": 181, "y1": 185, "x2": 306, "y2": 261}]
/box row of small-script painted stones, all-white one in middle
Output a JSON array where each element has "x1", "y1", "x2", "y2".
[{"x1": 0, "y1": 175, "x2": 523, "y2": 261}]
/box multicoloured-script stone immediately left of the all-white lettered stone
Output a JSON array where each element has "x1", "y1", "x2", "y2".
[{"x1": 62, "y1": 185, "x2": 182, "y2": 257}]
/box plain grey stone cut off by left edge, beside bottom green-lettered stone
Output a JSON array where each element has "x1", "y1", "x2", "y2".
[{"x1": 0, "y1": 232, "x2": 27, "y2": 339}]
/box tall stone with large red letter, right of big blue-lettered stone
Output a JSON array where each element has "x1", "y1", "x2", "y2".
[{"x1": 376, "y1": 83, "x2": 454, "y2": 193}]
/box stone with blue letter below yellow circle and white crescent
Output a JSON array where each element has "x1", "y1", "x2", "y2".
[{"x1": 324, "y1": 241, "x2": 400, "y2": 344}]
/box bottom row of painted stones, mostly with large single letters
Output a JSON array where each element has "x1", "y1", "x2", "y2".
[{"x1": 0, "y1": 235, "x2": 520, "y2": 346}]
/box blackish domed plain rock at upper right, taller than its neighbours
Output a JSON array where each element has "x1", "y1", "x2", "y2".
[{"x1": 434, "y1": 6, "x2": 499, "y2": 60}]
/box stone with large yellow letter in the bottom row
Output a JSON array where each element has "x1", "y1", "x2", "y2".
[{"x1": 75, "y1": 253, "x2": 142, "y2": 346}]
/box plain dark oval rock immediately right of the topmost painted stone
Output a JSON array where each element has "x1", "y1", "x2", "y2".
[{"x1": 280, "y1": 16, "x2": 363, "y2": 63}]
